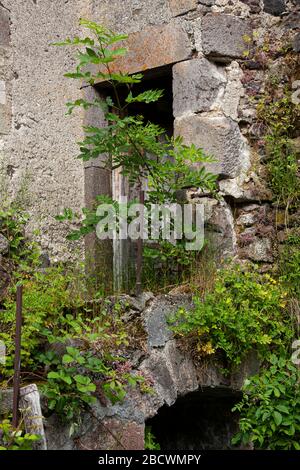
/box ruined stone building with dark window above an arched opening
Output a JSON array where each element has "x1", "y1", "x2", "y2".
[{"x1": 0, "y1": 0, "x2": 300, "y2": 448}]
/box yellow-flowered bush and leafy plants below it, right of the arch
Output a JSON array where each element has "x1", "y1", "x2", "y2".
[{"x1": 170, "y1": 265, "x2": 300, "y2": 450}]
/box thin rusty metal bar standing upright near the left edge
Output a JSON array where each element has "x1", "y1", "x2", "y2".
[{"x1": 12, "y1": 285, "x2": 23, "y2": 428}]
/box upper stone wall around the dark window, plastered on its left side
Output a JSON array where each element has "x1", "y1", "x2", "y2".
[{"x1": 0, "y1": 0, "x2": 300, "y2": 263}]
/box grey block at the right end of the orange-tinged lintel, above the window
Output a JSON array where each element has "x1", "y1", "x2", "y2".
[{"x1": 202, "y1": 13, "x2": 251, "y2": 62}]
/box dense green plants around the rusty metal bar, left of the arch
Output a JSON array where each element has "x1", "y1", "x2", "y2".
[{"x1": 0, "y1": 208, "x2": 151, "y2": 430}]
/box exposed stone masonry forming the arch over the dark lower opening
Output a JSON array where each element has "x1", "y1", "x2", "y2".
[{"x1": 45, "y1": 293, "x2": 258, "y2": 450}]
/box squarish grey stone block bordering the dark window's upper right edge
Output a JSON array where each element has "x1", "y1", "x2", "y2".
[{"x1": 173, "y1": 59, "x2": 226, "y2": 117}]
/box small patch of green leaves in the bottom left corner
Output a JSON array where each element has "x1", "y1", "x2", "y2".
[{"x1": 0, "y1": 419, "x2": 40, "y2": 450}]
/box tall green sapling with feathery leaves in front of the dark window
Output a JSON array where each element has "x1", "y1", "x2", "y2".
[{"x1": 56, "y1": 19, "x2": 216, "y2": 198}]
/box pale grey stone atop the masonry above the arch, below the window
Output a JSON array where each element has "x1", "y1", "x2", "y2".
[{"x1": 143, "y1": 295, "x2": 192, "y2": 348}]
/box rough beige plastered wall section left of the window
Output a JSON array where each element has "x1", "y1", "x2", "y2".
[{"x1": 0, "y1": 0, "x2": 94, "y2": 259}]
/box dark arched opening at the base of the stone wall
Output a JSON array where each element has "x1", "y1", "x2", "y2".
[{"x1": 146, "y1": 387, "x2": 241, "y2": 450}]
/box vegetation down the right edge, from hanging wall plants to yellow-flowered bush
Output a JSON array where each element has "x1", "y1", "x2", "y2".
[{"x1": 171, "y1": 36, "x2": 300, "y2": 450}]
